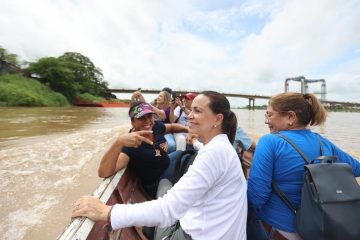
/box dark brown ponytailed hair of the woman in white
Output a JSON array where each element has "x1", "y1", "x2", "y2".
[{"x1": 201, "y1": 91, "x2": 237, "y2": 143}]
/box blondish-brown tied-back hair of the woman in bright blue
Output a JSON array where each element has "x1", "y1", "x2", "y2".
[{"x1": 269, "y1": 92, "x2": 327, "y2": 126}]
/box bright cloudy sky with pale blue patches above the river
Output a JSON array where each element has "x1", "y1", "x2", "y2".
[{"x1": 0, "y1": 0, "x2": 360, "y2": 102}]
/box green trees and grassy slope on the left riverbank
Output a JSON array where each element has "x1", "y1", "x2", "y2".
[{"x1": 0, "y1": 46, "x2": 112, "y2": 106}]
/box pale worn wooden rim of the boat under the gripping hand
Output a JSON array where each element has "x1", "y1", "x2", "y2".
[{"x1": 57, "y1": 169, "x2": 124, "y2": 240}]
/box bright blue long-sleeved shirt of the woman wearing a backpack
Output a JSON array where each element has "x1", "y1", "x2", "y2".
[{"x1": 248, "y1": 129, "x2": 360, "y2": 232}]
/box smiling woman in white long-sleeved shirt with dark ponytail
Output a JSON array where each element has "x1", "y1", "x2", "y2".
[{"x1": 72, "y1": 91, "x2": 247, "y2": 240}]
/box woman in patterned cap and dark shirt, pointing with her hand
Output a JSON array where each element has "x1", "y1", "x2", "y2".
[{"x1": 98, "y1": 102, "x2": 188, "y2": 198}]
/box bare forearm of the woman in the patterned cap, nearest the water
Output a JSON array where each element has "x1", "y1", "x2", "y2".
[{"x1": 98, "y1": 139, "x2": 123, "y2": 178}]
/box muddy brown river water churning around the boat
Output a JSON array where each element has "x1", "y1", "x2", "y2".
[{"x1": 0, "y1": 107, "x2": 360, "y2": 240}]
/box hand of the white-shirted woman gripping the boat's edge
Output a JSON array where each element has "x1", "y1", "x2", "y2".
[{"x1": 71, "y1": 196, "x2": 111, "y2": 221}]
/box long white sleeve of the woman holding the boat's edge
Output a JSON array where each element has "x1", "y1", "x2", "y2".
[{"x1": 111, "y1": 148, "x2": 221, "y2": 229}]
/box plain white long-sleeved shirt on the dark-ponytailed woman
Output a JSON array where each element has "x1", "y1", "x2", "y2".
[{"x1": 111, "y1": 134, "x2": 247, "y2": 240}]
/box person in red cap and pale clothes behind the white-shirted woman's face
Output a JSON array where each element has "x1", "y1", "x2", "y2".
[{"x1": 169, "y1": 93, "x2": 197, "y2": 151}]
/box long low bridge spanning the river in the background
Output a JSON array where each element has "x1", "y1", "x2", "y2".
[{"x1": 109, "y1": 88, "x2": 360, "y2": 110}]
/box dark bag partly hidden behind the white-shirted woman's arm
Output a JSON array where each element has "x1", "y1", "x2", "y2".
[{"x1": 171, "y1": 149, "x2": 197, "y2": 184}]
